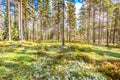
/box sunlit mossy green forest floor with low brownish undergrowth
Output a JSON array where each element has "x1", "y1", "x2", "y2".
[{"x1": 0, "y1": 41, "x2": 120, "y2": 80}]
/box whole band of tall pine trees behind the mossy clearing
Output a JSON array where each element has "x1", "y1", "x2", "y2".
[{"x1": 0, "y1": 0, "x2": 120, "y2": 46}]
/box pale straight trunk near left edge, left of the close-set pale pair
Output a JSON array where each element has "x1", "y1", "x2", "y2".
[{"x1": 7, "y1": 0, "x2": 11, "y2": 41}]
